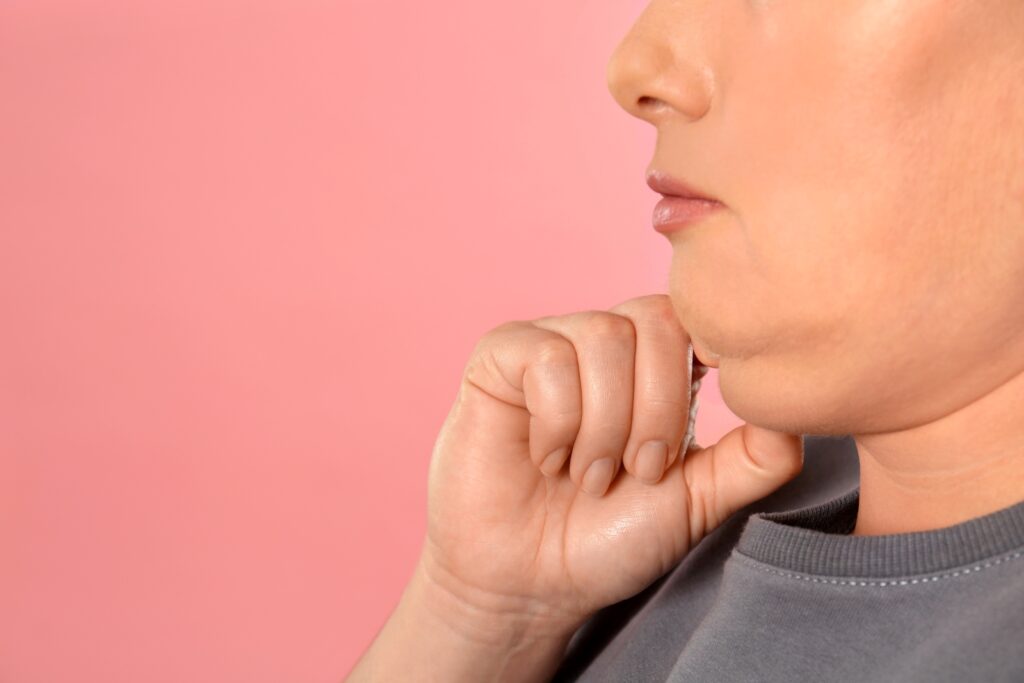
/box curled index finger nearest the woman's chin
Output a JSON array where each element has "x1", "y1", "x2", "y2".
[{"x1": 610, "y1": 294, "x2": 693, "y2": 483}]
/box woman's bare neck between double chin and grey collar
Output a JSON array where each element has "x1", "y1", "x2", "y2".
[{"x1": 852, "y1": 368, "x2": 1024, "y2": 536}]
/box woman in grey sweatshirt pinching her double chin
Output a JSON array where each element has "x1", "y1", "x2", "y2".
[{"x1": 349, "y1": 0, "x2": 1024, "y2": 681}]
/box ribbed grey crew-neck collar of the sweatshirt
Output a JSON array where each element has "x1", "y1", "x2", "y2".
[{"x1": 735, "y1": 485, "x2": 1024, "y2": 578}]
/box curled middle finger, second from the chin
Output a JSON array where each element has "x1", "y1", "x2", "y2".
[{"x1": 535, "y1": 310, "x2": 636, "y2": 497}]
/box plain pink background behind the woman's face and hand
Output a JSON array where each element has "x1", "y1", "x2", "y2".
[{"x1": 0, "y1": 0, "x2": 739, "y2": 683}]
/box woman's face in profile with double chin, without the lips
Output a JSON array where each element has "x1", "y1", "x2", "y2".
[{"x1": 607, "y1": 0, "x2": 1024, "y2": 434}]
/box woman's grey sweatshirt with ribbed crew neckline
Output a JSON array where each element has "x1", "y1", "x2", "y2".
[{"x1": 552, "y1": 435, "x2": 1024, "y2": 683}]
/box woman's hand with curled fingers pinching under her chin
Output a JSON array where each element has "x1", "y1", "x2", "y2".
[{"x1": 420, "y1": 294, "x2": 803, "y2": 625}]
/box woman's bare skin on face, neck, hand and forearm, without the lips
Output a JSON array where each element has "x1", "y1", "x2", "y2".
[{"x1": 348, "y1": 0, "x2": 1024, "y2": 683}]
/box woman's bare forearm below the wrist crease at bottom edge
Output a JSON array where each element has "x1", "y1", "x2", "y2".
[{"x1": 346, "y1": 566, "x2": 583, "y2": 683}]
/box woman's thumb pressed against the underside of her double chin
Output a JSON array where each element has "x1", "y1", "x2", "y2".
[{"x1": 682, "y1": 423, "x2": 804, "y2": 547}]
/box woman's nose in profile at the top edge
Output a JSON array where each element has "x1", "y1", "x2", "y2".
[{"x1": 606, "y1": 0, "x2": 718, "y2": 126}]
